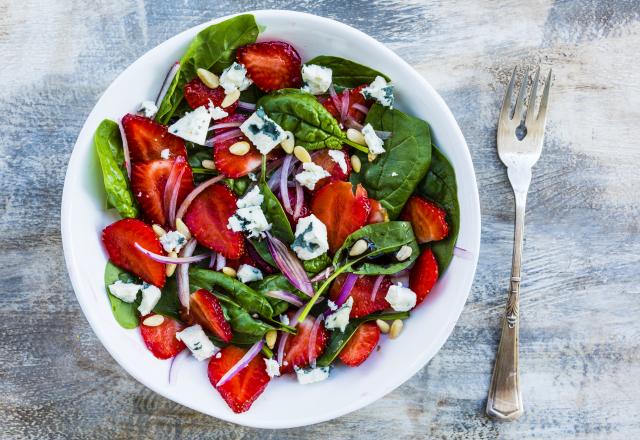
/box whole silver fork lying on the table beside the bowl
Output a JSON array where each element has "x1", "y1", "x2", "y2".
[{"x1": 487, "y1": 67, "x2": 551, "y2": 420}]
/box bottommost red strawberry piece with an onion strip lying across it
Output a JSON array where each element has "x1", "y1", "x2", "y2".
[{"x1": 209, "y1": 345, "x2": 270, "y2": 413}]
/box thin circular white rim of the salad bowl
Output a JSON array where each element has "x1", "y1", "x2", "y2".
[{"x1": 60, "y1": 9, "x2": 481, "y2": 429}]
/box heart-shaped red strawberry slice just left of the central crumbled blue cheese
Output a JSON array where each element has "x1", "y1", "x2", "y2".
[{"x1": 182, "y1": 183, "x2": 244, "y2": 259}]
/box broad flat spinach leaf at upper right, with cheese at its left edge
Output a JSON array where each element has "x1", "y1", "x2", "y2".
[{"x1": 351, "y1": 104, "x2": 431, "y2": 220}]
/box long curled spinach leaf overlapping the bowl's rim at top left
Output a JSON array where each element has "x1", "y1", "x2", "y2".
[{"x1": 156, "y1": 14, "x2": 259, "y2": 124}]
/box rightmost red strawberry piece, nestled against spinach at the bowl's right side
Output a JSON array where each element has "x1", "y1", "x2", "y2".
[{"x1": 400, "y1": 196, "x2": 449, "y2": 243}]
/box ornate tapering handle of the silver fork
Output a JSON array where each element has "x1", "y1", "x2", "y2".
[{"x1": 487, "y1": 191, "x2": 527, "y2": 420}]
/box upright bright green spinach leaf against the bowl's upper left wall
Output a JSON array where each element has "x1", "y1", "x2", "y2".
[{"x1": 93, "y1": 119, "x2": 138, "y2": 218}]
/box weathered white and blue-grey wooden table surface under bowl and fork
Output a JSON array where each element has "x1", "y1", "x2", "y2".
[{"x1": 0, "y1": 0, "x2": 640, "y2": 439}]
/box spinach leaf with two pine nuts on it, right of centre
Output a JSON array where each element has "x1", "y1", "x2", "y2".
[{"x1": 333, "y1": 221, "x2": 420, "y2": 275}]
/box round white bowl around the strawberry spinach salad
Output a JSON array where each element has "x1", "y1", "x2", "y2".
[{"x1": 62, "y1": 10, "x2": 480, "y2": 428}]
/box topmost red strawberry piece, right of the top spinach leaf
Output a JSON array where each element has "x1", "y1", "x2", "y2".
[{"x1": 236, "y1": 41, "x2": 302, "y2": 92}]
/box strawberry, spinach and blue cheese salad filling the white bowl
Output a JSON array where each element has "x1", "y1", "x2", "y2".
[{"x1": 94, "y1": 15, "x2": 460, "y2": 413}]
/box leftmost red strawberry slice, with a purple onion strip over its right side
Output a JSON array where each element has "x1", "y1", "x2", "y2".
[{"x1": 102, "y1": 218, "x2": 166, "y2": 287}]
